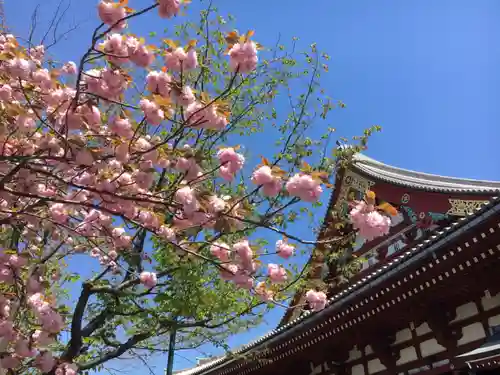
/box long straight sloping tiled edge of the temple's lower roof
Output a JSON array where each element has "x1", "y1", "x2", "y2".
[{"x1": 173, "y1": 197, "x2": 500, "y2": 375}]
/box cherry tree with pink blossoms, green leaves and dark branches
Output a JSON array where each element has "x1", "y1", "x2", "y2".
[{"x1": 0, "y1": 0, "x2": 390, "y2": 375}]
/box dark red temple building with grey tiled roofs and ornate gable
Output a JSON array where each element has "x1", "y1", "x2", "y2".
[{"x1": 178, "y1": 154, "x2": 500, "y2": 375}]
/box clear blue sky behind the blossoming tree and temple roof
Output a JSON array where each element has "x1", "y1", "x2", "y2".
[{"x1": 5, "y1": 0, "x2": 500, "y2": 374}]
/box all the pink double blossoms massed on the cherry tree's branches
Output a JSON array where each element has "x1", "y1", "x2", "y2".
[{"x1": 0, "y1": 0, "x2": 385, "y2": 375}]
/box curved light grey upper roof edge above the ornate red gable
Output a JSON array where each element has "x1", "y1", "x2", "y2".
[{"x1": 352, "y1": 154, "x2": 500, "y2": 194}]
